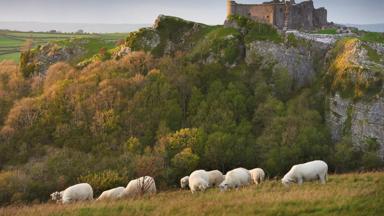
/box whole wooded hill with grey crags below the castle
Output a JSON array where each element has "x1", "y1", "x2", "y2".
[{"x1": 0, "y1": 13, "x2": 384, "y2": 208}]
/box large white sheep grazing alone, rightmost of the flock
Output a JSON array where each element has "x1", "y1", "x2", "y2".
[{"x1": 281, "y1": 160, "x2": 328, "y2": 186}]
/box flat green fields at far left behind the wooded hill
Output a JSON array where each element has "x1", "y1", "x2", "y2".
[{"x1": 0, "y1": 30, "x2": 127, "y2": 62}]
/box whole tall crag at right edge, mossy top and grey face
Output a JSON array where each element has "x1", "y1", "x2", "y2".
[{"x1": 327, "y1": 40, "x2": 384, "y2": 159}]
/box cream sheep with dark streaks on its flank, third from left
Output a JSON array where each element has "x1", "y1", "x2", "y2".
[{"x1": 121, "y1": 176, "x2": 156, "y2": 198}]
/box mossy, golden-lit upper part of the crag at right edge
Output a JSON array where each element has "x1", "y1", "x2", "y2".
[{"x1": 325, "y1": 38, "x2": 384, "y2": 100}]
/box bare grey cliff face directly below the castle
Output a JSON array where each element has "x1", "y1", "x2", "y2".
[{"x1": 245, "y1": 41, "x2": 315, "y2": 88}]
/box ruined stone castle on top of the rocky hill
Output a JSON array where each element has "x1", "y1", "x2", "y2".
[{"x1": 227, "y1": 0, "x2": 328, "y2": 30}]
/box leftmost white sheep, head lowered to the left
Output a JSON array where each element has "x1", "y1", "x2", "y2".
[{"x1": 51, "y1": 183, "x2": 93, "y2": 204}]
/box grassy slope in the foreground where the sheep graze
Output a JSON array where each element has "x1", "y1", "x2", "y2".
[{"x1": 0, "y1": 173, "x2": 384, "y2": 216}]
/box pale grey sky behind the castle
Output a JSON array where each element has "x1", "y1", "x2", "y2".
[{"x1": 0, "y1": 0, "x2": 384, "y2": 24}]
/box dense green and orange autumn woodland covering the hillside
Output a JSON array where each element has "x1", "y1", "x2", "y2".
[{"x1": 0, "y1": 16, "x2": 382, "y2": 204}]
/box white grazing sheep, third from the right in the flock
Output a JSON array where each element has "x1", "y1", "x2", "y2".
[{"x1": 219, "y1": 168, "x2": 251, "y2": 191}]
